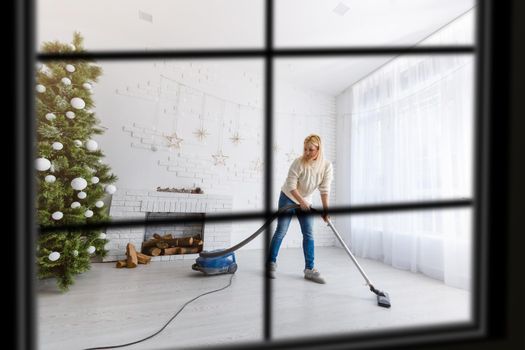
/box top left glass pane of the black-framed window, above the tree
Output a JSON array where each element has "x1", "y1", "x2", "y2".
[{"x1": 36, "y1": 0, "x2": 264, "y2": 51}]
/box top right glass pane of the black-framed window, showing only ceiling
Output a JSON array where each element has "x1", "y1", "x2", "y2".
[{"x1": 275, "y1": 0, "x2": 476, "y2": 47}]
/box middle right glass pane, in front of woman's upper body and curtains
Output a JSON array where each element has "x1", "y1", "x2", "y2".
[{"x1": 274, "y1": 55, "x2": 474, "y2": 208}]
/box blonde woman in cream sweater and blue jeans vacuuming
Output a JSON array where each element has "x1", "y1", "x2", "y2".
[{"x1": 267, "y1": 134, "x2": 333, "y2": 283}]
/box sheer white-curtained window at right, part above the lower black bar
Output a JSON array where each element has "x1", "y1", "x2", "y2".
[{"x1": 341, "y1": 56, "x2": 474, "y2": 204}]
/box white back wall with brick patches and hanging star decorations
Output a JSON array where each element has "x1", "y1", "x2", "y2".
[{"x1": 93, "y1": 60, "x2": 335, "y2": 252}]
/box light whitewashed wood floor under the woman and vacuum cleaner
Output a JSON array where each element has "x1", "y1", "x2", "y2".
[{"x1": 37, "y1": 247, "x2": 471, "y2": 349}]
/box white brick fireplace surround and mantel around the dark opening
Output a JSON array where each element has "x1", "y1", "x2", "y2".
[{"x1": 103, "y1": 189, "x2": 232, "y2": 261}]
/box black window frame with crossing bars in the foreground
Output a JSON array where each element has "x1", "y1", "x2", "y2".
[{"x1": 13, "y1": 0, "x2": 509, "y2": 349}]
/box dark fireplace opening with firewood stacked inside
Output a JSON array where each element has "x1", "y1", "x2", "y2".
[{"x1": 141, "y1": 212, "x2": 205, "y2": 256}]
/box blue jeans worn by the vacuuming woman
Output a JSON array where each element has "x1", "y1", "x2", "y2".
[{"x1": 268, "y1": 192, "x2": 314, "y2": 269}]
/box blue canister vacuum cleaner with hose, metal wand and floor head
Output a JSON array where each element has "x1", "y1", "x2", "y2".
[{"x1": 192, "y1": 204, "x2": 391, "y2": 308}]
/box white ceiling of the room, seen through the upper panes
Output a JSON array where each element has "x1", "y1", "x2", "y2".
[{"x1": 36, "y1": 0, "x2": 475, "y2": 96}]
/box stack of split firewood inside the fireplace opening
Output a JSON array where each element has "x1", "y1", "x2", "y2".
[{"x1": 142, "y1": 233, "x2": 203, "y2": 256}]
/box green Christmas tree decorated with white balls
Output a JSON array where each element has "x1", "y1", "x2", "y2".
[{"x1": 36, "y1": 33, "x2": 117, "y2": 291}]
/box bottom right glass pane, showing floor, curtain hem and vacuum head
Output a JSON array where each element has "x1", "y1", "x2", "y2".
[{"x1": 273, "y1": 209, "x2": 475, "y2": 340}]
